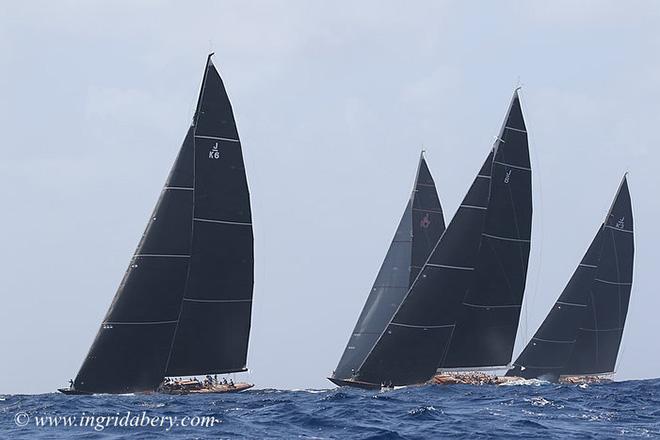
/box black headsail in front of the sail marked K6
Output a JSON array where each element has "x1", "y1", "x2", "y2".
[{"x1": 74, "y1": 128, "x2": 194, "y2": 393}]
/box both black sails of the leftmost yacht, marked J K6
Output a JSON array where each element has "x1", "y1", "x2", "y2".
[{"x1": 73, "y1": 54, "x2": 254, "y2": 393}]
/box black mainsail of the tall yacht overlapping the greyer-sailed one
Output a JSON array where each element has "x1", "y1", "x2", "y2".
[{"x1": 440, "y1": 91, "x2": 532, "y2": 369}]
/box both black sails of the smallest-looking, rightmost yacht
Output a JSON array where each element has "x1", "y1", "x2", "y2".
[{"x1": 507, "y1": 176, "x2": 634, "y2": 381}]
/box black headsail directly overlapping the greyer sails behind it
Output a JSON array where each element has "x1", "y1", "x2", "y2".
[{"x1": 353, "y1": 152, "x2": 493, "y2": 385}]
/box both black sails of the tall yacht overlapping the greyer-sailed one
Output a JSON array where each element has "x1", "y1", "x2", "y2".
[{"x1": 354, "y1": 91, "x2": 532, "y2": 385}]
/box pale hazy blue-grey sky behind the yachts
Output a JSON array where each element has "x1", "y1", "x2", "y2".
[{"x1": 0, "y1": 0, "x2": 660, "y2": 393}]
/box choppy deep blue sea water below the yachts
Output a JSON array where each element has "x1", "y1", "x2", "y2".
[{"x1": 0, "y1": 380, "x2": 660, "y2": 439}]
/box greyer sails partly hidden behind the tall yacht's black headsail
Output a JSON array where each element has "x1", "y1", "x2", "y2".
[{"x1": 330, "y1": 154, "x2": 445, "y2": 385}]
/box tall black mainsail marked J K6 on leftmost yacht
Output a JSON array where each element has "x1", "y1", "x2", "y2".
[{"x1": 166, "y1": 57, "x2": 254, "y2": 376}]
